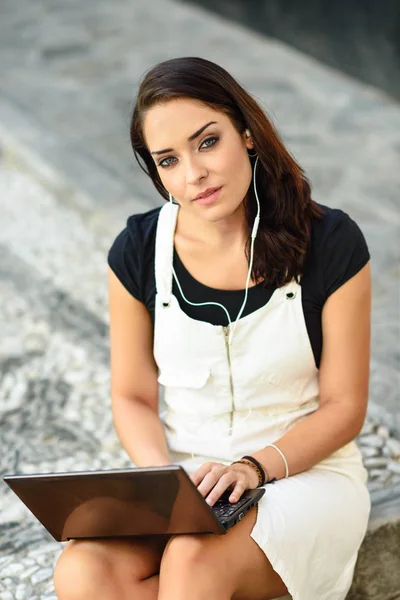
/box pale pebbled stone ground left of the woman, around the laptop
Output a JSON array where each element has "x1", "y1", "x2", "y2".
[{"x1": 0, "y1": 162, "x2": 131, "y2": 600}]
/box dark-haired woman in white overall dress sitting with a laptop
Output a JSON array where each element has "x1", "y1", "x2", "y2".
[{"x1": 55, "y1": 58, "x2": 371, "y2": 600}]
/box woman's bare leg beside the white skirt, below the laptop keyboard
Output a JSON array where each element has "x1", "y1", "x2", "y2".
[{"x1": 158, "y1": 507, "x2": 287, "y2": 600}]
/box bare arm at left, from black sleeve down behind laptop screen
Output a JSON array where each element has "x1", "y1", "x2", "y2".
[{"x1": 108, "y1": 267, "x2": 171, "y2": 467}]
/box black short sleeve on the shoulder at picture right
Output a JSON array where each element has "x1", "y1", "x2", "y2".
[{"x1": 321, "y1": 212, "x2": 370, "y2": 300}]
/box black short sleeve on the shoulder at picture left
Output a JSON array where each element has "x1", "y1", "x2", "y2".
[{"x1": 107, "y1": 227, "x2": 143, "y2": 302}]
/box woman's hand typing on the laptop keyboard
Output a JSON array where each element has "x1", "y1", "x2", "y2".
[{"x1": 190, "y1": 462, "x2": 258, "y2": 506}]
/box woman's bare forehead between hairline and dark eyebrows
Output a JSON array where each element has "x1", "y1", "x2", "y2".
[{"x1": 143, "y1": 98, "x2": 230, "y2": 151}]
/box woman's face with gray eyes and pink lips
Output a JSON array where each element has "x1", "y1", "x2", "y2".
[{"x1": 143, "y1": 98, "x2": 252, "y2": 222}]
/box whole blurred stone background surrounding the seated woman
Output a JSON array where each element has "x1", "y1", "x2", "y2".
[{"x1": 0, "y1": 0, "x2": 400, "y2": 600}]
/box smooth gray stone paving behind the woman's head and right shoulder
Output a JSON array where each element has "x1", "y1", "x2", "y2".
[{"x1": 0, "y1": 0, "x2": 400, "y2": 431}]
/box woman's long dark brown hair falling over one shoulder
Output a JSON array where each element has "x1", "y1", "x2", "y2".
[{"x1": 130, "y1": 57, "x2": 322, "y2": 288}]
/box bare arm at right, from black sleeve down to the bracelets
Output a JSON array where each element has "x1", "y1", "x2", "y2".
[{"x1": 252, "y1": 263, "x2": 371, "y2": 479}]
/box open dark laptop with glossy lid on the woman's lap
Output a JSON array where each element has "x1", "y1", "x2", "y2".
[{"x1": 3, "y1": 465, "x2": 265, "y2": 542}]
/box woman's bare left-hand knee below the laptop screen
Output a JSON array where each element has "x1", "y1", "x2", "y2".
[{"x1": 54, "y1": 541, "x2": 112, "y2": 600}]
